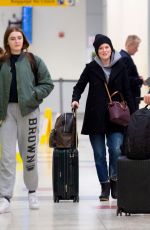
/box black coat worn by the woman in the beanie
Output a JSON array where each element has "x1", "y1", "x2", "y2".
[{"x1": 72, "y1": 60, "x2": 135, "y2": 134}]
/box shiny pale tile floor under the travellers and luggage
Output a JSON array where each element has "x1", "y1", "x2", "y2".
[{"x1": 0, "y1": 117, "x2": 150, "y2": 230}]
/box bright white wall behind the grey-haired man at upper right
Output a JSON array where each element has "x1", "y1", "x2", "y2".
[{"x1": 107, "y1": 0, "x2": 148, "y2": 84}]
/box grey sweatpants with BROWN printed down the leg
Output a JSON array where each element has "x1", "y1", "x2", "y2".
[{"x1": 0, "y1": 103, "x2": 39, "y2": 198}]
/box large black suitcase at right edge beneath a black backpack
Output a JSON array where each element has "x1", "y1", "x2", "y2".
[{"x1": 117, "y1": 156, "x2": 150, "y2": 216}]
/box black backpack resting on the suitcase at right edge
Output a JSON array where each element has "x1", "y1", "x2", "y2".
[{"x1": 124, "y1": 106, "x2": 150, "y2": 160}]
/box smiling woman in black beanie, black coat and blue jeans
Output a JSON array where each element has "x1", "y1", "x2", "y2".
[{"x1": 72, "y1": 34, "x2": 134, "y2": 201}]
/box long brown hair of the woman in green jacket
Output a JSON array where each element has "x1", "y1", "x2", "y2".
[{"x1": 3, "y1": 26, "x2": 29, "y2": 56}]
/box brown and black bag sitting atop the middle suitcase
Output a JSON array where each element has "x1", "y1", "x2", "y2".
[{"x1": 49, "y1": 112, "x2": 77, "y2": 148}]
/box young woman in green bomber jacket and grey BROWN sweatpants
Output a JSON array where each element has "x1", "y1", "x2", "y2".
[{"x1": 0, "y1": 27, "x2": 54, "y2": 213}]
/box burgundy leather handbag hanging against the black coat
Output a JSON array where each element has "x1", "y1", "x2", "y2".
[{"x1": 105, "y1": 83, "x2": 130, "y2": 126}]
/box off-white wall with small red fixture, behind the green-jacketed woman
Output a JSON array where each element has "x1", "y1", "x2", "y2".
[{"x1": 0, "y1": 0, "x2": 86, "y2": 79}]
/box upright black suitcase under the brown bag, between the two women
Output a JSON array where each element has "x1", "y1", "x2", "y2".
[{"x1": 52, "y1": 148, "x2": 79, "y2": 202}]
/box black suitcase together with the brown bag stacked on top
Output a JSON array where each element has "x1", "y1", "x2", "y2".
[{"x1": 50, "y1": 111, "x2": 79, "y2": 202}]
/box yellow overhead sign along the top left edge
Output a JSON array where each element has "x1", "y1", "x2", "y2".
[{"x1": 0, "y1": 0, "x2": 76, "y2": 6}]
